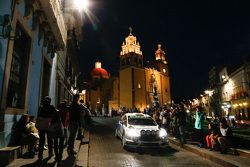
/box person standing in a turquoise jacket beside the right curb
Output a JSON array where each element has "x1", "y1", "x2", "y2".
[{"x1": 195, "y1": 106, "x2": 205, "y2": 147}]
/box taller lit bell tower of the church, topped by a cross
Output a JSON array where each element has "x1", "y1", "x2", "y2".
[{"x1": 120, "y1": 27, "x2": 143, "y2": 69}]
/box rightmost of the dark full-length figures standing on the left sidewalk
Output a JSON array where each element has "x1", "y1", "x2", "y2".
[{"x1": 67, "y1": 94, "x2": 81, "y2": 155}]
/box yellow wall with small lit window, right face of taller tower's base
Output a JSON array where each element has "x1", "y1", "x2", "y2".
[{"x1": 134, "y1": 68, "x2": 147, "y2": 112}]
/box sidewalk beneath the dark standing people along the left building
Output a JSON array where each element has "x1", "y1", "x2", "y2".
[{"x1": 7, "y1": 131, "x2": 89, "y2": 167}]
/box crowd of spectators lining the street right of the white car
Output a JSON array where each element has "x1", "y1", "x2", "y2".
[{"x1": 118, "y1": 103, "x2": 236, "y2": 154}]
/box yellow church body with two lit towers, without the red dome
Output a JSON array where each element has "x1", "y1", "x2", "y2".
[{"x1": 109, "y1": 28, "x2": 171, "y2": 111}]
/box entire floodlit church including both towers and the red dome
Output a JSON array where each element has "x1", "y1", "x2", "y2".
[{"x1": 88, "y1": 28, "x2": 171, "y2": 113}]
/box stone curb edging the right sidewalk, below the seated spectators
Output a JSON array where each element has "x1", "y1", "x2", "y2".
[{"x1": 169, "y1": 138, "x2": 238, "y2": 167}]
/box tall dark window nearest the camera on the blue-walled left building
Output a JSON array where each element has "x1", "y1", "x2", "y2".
[{"x1": 7, "y1": 24, "x2": 31, "y2": 109}]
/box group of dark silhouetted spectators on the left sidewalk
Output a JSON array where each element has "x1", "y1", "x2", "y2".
[{"x1": 11, "y1": 95, "x2": 91, "y2": 166}]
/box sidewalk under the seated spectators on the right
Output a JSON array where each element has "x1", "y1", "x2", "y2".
[{"x1": 169, "y1": 137, "x2": 250, "y2": 167}]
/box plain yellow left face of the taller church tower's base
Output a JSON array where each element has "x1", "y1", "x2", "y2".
[{"x1": 119, "y1": 68, "x2": 133, "y2": 108}]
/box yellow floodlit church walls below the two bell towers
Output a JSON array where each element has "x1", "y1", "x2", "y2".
[{"x1": 119, "y1": 67, "x2": 171, "y2": 111}]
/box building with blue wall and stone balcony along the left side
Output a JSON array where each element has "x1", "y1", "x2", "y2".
[{"x1": 0, "y1": 0, "x2": 82, "y2": 148}]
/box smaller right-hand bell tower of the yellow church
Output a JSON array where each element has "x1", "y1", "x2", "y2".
[{"x1": 150, "y1": 44, "x2": 169, "y2": 76}]
